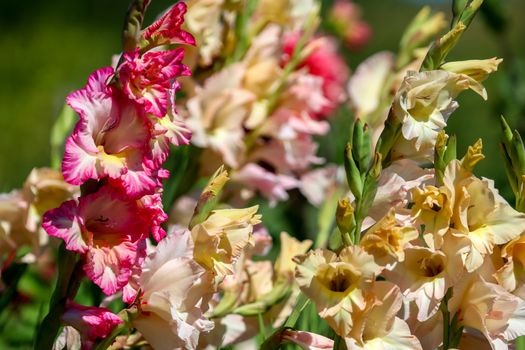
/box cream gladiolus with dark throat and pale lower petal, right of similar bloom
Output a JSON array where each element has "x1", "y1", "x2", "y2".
[{"x1": 384, "y1": 237, "x2": 465, "y2": 321}]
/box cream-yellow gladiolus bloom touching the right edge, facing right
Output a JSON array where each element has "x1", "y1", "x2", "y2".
[{"x1": 444, "y1": 161, "x2": 525, "y2": 272}]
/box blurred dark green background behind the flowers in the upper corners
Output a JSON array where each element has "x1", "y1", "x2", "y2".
[{"x1": 0, "y1": 0, "x2": 525, "y2": 197}]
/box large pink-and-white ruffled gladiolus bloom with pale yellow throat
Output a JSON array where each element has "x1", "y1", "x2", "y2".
[{"x1": 62, "y1": 68, "x2": 157, "y2": 197}]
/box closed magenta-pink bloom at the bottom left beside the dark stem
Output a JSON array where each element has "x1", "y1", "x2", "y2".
[{"x1": 62, "y1": 301, "x2": 124, "y2": 349}]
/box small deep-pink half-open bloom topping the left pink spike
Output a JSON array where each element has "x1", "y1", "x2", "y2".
[{"x1": 142, "y1": 2, "x2": 195, "y2": 46}]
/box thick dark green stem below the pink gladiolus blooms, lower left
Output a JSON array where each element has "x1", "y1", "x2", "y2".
[{"x1": 35, "y1": 246, "x2": 83, "y2": 350}]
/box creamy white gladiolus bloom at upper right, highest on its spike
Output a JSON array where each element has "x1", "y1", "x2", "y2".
[{"x1": 392, "y1": 70, "x2": 486, "y2": 150}]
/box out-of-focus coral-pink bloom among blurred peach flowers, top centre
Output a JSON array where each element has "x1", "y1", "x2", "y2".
[{"x1": 283, "y1": 33, "x2": 349, "y2": 118}]
